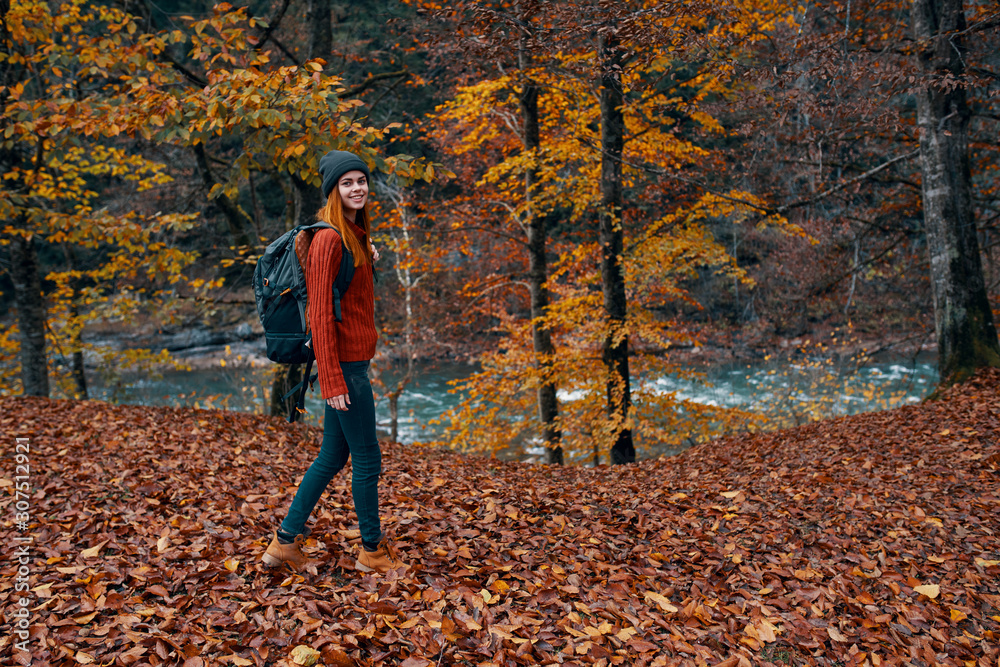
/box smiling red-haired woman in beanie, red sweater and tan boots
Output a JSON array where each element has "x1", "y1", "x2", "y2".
[{"x1": 262, "y1": 151, "x2": 405, "y2": 572}]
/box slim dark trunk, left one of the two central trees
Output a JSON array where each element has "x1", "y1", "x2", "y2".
[{"x1": 519, "y1": 27, "x2": 563, "y2": 465}]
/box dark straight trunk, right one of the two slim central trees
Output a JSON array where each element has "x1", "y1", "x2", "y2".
[{"x1": 597, "y1": 27, "x2": 635, "y2": 465}]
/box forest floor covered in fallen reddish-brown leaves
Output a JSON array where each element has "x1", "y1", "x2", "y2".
[{"x1": 0, "y1": 372, "x2": 1000, "y2": 667}]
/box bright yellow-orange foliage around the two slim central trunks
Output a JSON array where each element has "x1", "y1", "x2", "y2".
[{"x1": 416, "y1": 1, "x2": 803, "y2": 459}]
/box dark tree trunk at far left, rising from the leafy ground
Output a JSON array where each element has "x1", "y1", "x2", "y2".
[{"x1": 10, "y1": 236, "x2": 49, "y2": 397}]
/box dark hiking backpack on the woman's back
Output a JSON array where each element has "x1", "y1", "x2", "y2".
[{"x1": 253, "y1": 222, "x2": 354, "y2": 422}]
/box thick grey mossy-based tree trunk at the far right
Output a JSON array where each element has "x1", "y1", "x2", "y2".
[{"x1": 911, "y1": 0, "x2": 1000, "y2": 387}]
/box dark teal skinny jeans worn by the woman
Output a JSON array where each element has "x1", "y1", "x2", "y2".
[{"x1": 281, "y1": 361, "x2": 382, "y2": 550}]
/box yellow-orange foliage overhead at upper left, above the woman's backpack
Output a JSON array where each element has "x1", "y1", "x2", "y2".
[{"x1": 0, "y1": 0, "x2": 448, "y2": 396}]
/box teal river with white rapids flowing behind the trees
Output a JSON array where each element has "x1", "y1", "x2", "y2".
[{"x1": 91, "y1": 355, "x2": 937, "y2": 452}]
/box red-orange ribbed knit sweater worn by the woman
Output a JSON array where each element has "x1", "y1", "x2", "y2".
[{"x1": 306, "y1": 223, "x2": 378, "y2": 400}]
